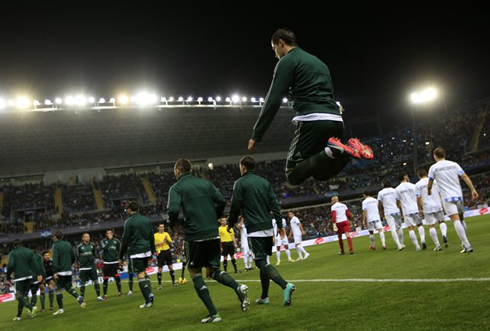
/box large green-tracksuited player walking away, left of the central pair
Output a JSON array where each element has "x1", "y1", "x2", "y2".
[{"x1": 167, "y1": 159, "x2": 250, "y2": 323}]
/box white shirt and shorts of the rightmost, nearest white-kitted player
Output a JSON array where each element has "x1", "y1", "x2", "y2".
[{"x1": 429, "y1": 160, "x2": 464, "y2": 216}]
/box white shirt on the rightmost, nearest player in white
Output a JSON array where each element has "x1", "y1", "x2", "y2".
[{"x1": 429, "y1": 160, "x2": 464, "y2": 201}]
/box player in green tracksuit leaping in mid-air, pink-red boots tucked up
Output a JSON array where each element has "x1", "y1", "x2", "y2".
[{"x1": 248, "y1": 28, "x2": 372, "y2": 188}]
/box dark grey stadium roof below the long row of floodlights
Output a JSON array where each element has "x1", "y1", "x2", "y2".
[{"x1": 0, "y1": 106, "x2": 294, "y2": 177}]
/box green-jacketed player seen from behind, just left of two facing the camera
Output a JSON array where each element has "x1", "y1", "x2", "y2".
[{"x1": 52, "y1": 231, "x2": 87, "y2": 315}]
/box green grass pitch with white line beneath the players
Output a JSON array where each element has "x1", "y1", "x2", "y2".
[{"x1": 0, "y1": 215, "x2": 490, "y2": 331}]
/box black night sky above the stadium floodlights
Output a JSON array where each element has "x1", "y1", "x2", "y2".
[{"x1": 0, "y1": 1, "x2": 490, "y2": 134}]
